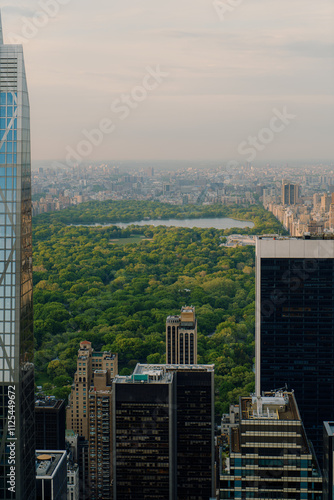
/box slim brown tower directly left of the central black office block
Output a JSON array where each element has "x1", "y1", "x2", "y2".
[{"x1": 88, "y1": 370, "x2": 113, "y2": 500}]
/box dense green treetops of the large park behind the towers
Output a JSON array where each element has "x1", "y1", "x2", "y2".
[{"x1": 34, "y1": 202, "x2": 282, "y2": 413}]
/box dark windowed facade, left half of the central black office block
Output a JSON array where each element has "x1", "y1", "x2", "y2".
[{"x1": 114, "y1": 383, "x2": 173, "y2": 500}]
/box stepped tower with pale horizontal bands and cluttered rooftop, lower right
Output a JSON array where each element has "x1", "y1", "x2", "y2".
[{"x1": 220, "y1": 391, "x2": 322, "y2": 500}]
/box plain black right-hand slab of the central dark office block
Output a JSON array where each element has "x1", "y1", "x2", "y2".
[{"x1": 167, "y1": 365, "x2": 215, "y2": 500}]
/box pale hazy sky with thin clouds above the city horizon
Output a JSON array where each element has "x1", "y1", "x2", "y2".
[{"x1": 0, "y1": 0, "x2": 334, "y2": 165}]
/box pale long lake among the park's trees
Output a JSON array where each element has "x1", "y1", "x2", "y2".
[{"x1": 87, "y1": 217, "x2": 254, "y2": 229}]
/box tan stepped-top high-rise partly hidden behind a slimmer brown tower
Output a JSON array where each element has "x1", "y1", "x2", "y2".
[{"x1": 66, "y1": 340, "x2": 118, "y2": 440}]
